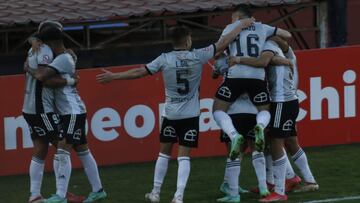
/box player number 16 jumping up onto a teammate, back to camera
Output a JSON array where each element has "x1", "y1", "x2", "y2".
[{"x1": 213, "y1": 6, "x2": 291, "y2": 162}]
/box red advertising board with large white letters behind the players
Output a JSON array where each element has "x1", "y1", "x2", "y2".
[{"x1": 0, "y1": 47, "x2": 360, "y2": 175}]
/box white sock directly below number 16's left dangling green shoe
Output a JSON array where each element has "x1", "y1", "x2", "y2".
[{"x1": 225, "y1": 158, "x2": 240, "y2": 196}]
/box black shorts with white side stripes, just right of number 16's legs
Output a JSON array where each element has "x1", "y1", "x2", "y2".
[{"x1": 269, "y1": 99, "x2": 299, "y2": 138}]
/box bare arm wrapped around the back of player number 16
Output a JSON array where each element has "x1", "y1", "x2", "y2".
[{"x1": 229, "y1": 51, "x2": 275, "y2": 68}]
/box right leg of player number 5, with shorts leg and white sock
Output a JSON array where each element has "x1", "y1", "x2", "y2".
[{"x1": 172, "y1": 117, "x2": 199, "y2": 203}]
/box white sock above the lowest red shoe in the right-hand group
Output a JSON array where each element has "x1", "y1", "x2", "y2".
[{"x1": 273, "y1": 155, "x2": 286, "y2": 195}]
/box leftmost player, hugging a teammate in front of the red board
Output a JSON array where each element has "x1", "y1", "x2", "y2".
[{"x1": 22, "y1": 30, "x2": 81, "y2": 203}]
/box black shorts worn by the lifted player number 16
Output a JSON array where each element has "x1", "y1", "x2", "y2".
[{"x1": 215, "y1": 78, "x2": 270, "y2": 106}]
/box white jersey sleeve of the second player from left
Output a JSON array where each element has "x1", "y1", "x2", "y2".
[{"x1": 48, "y1": 54, "x2": 75, "y2": 74}]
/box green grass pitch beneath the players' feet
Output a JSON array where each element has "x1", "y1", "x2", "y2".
[{"x1": 0, "y1": 144, "x2": 360, "y2": 203}]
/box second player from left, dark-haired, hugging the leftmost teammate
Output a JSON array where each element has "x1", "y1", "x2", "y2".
[{"x1": 29, "y1": 21, "x2": 107, "y2": 203}]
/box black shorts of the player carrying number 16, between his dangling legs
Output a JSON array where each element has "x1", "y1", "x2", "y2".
[{"x1": 220, "y1": 113, "x2": 256, "y2": 143}]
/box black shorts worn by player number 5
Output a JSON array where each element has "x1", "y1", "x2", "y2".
[{"x1": 160, "y1": 117, "x2": 199, "y2": 148}]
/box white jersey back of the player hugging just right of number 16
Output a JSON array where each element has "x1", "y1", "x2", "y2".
[{"x1": 264, "y1": 40, "x2": 298, "y2": 102}]
